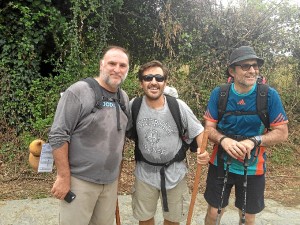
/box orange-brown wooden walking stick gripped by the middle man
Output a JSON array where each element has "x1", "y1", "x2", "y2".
[{"x1": 186, "y1": 130, "x2": 208, "y2": 225}]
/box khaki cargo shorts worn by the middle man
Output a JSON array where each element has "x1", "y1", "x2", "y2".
[{"x1": 132, "y1": 178, "x2": 190, "y2": 222}]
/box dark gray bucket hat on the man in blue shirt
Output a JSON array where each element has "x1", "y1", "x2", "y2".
[{"x1": 229, "y1": 46, "x2": 264, "y2": 66}]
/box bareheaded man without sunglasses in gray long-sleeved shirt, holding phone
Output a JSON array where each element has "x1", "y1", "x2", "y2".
[{"x1": 49, "y1": 46, "x2": 129, "y2": 225}]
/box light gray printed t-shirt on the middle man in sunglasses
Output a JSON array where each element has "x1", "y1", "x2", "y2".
[{"x1": 130, "y1": 97, "x2": 204, "y2": 189}]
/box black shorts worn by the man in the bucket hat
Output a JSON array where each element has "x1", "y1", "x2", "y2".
[{"x1": 204, "y1": 164, "x2": 265, "y2": 214}]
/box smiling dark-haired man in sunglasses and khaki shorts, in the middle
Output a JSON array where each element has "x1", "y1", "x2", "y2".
[{"x1": 129, "y1": 60, "x2": 209, "y2": 225}]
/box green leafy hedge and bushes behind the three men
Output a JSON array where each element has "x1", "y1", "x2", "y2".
[{"x1": 0, "y1": 0, "x2": 300, "y2": 165}]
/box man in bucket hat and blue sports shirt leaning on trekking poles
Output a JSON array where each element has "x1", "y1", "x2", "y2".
[{"x1": 204, "y1": 46, "x2": 288, "y2": 225}]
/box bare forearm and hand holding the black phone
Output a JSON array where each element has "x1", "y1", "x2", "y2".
[{"x1": 51, "y1": 142, "x2": 71, "y2": 200}]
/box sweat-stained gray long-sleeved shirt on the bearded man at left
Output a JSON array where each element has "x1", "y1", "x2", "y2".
[{"x1": 49, "y1": 81, "x2": 129, "y2": 184}]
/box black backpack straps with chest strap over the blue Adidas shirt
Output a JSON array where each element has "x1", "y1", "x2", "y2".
[{"x1": 218, "y1": 76, "x2": 270, "y2": 129}]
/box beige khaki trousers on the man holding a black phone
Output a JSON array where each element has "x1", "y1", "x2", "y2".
[{"x1": 59, "y1": 177, "x2": 118, "y2": 225}]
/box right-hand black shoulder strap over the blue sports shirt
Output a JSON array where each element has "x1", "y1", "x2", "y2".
[{"x1": 256, "y1": 83, "x2": 270, "y2": 129}]
